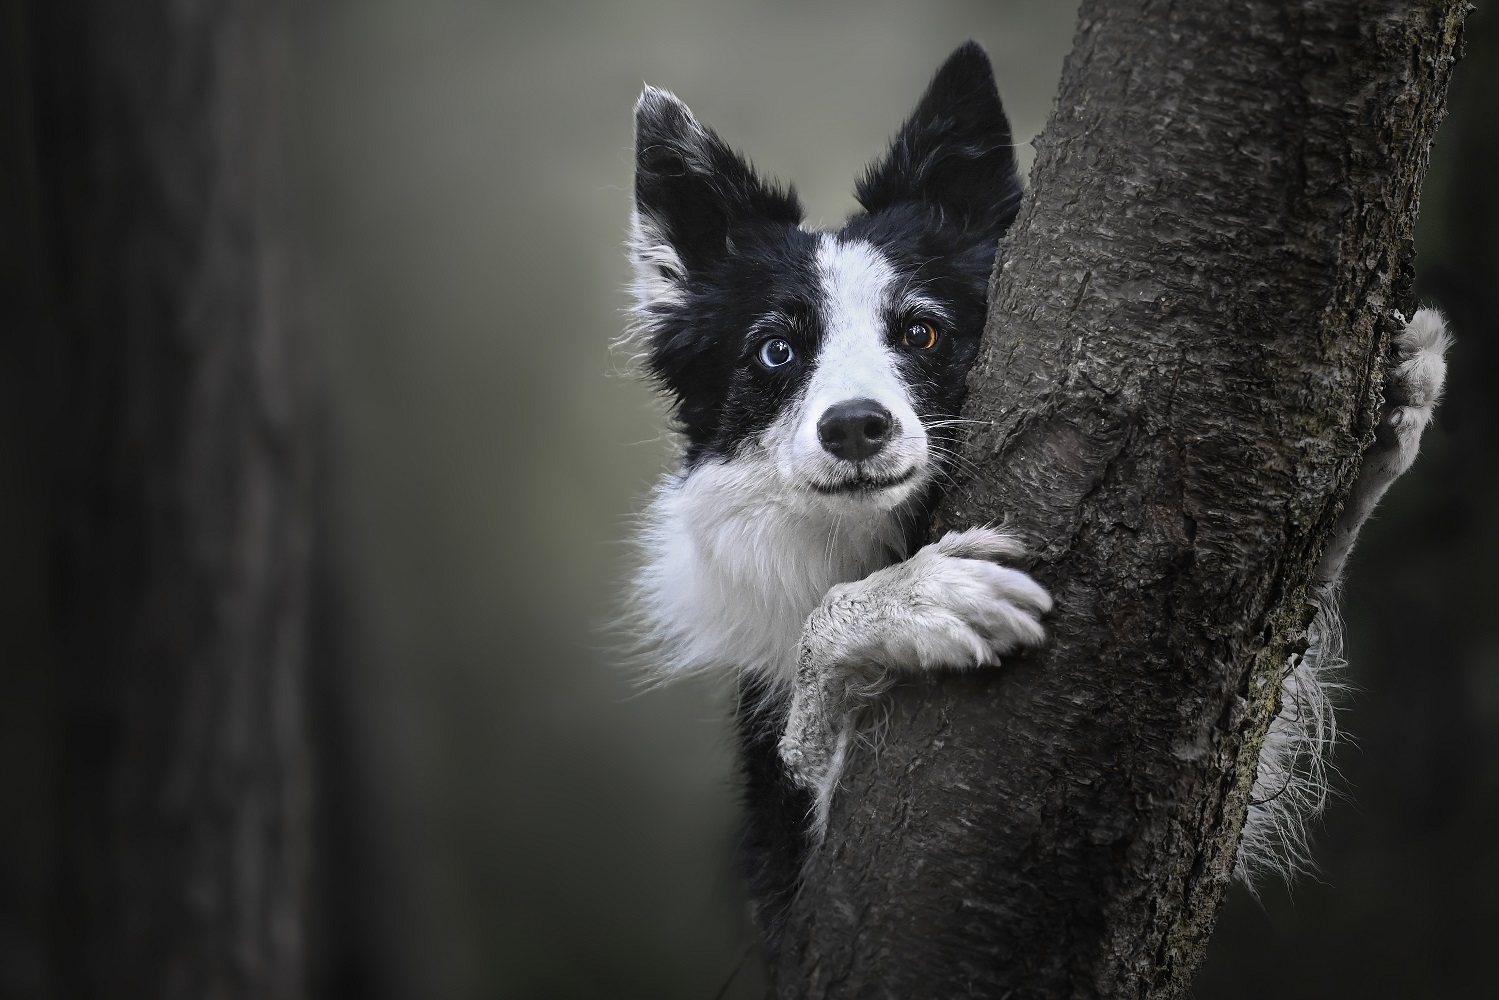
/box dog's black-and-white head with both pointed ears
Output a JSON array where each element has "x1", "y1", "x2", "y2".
[{"x1": 633, "y1": 42, "x2": 1021, "y2": 511}]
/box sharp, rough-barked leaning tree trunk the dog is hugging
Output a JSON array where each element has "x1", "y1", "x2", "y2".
[{"x1": 775, "y1": 0, "x2": 1466, "y2": 1000}]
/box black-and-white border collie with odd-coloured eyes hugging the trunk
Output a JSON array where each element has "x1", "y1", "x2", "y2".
[{"x1": 627, "y1": 42, "x2": 1447, "y2": 939}]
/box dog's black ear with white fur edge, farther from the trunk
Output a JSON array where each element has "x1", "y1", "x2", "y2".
[{"x1": 631, "y1": 87, "x2": 802, "y2": 310}]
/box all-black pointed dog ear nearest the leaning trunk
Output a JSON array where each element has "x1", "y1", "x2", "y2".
[{"x1": 856, "y1": 42, "x2": 1022, "y2": 232}]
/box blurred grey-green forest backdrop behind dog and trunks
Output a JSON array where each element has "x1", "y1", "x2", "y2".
[{"x1": 0, "y1": 0, "x2": 1499, "y2": 1000}]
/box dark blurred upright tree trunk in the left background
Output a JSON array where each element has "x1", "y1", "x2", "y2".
[{"x1": 25, "y1": 0, "x2": 318, "y2": 1000}]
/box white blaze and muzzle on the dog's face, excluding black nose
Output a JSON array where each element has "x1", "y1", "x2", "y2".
[{"x1": 782, "y1": 234, "x2": 926, "y2": 504}]
